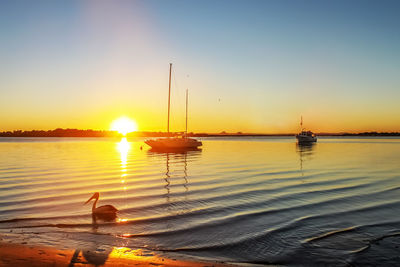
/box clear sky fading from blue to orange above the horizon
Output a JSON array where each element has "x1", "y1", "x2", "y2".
[{"x1": 0, "y1": 0, "x2": 400, "y2": 133}]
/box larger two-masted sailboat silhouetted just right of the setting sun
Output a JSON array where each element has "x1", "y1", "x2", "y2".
[{"x1": 145, "y1": 63, "x2": 203, "y2": 150}]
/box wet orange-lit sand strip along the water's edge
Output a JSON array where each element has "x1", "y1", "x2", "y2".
[{"x1": 0, "y1": 242, "x2": 234, "y2": 267}]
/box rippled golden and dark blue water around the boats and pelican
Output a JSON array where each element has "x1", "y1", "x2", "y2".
[{"x1": 0, "y1": 137, "x2": 400, "y2": 266}]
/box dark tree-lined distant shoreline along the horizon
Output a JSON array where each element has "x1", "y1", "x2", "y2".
[{"x1": 0, "y1": 128, "x2": 400, "y2": 137}]
